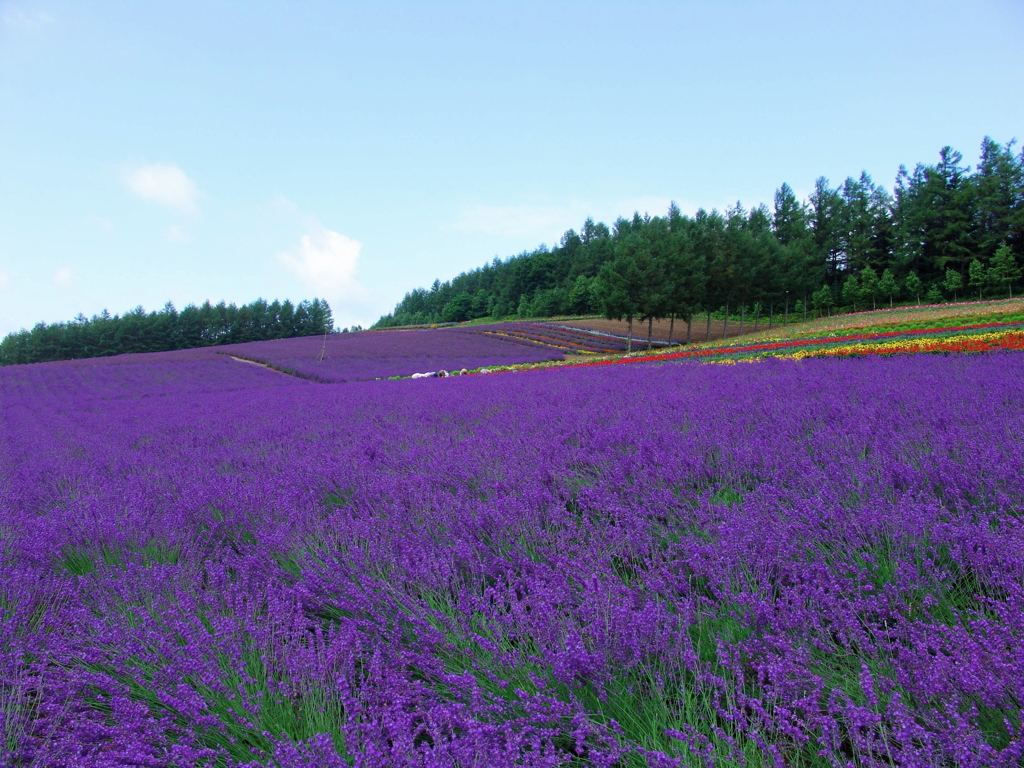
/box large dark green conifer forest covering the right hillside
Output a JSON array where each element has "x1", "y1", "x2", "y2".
[{"x1": 374, "y1": 137, "x2": 1024, "y2": 335}]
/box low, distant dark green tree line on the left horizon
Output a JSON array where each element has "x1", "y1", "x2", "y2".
[{"x1": 0, "y1": 299, "x2": 334, "y2": 366}]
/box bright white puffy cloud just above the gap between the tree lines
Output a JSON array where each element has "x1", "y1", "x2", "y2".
[{"x1": 278, "y1": 225, "x2": 365, "y2": 301}]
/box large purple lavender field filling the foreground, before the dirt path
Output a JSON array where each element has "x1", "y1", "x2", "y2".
[{"x1": 0, "y1": 352, "x2": 1024, "y2": 768}]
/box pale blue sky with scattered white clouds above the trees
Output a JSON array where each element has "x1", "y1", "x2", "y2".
[{"x1": 0, "y1": 0, "x2": 1024, "y2": 334}]
